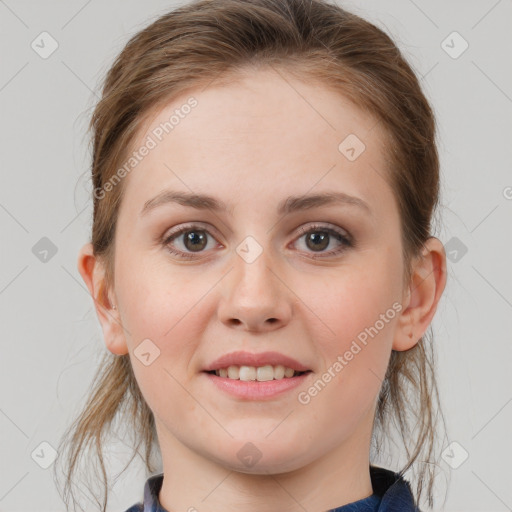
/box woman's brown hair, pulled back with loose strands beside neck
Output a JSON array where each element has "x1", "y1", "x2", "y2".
[{"x1": 54, "y1": 0, "x2": 448, "y2": 511}]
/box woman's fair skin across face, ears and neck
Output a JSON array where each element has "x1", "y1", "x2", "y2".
[{"x1": 78, "y1": 70, "x2": 446, "y2": 512}]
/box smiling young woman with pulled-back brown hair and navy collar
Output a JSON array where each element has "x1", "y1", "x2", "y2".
[{"x1": 56, "y1": 0, "x2": 446, "y2": 512}]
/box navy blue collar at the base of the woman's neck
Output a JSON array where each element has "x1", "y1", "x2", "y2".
[{"x1": 126, "y1": 466, "x2": 421, "y2": 512}]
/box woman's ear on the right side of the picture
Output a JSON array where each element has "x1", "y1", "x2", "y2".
[{"x1": 393, "y1": 237, "x2": 447, "y2": 351}]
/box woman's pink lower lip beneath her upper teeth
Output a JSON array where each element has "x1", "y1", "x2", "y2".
[{"x1": 204, "y1": 372, "x2": 311, "y2": 400}]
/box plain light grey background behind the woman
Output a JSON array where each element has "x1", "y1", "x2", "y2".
[{"x1": 0, "y1": 0, "x2": 512, "y2": 512}]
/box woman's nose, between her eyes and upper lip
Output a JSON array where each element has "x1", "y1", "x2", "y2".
[{"x1": 218, "y1": 243, "x2": 293, "y2": 332}]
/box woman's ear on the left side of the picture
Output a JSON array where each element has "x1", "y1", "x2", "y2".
[{"x1": 77, "y1": 243, "x2": 128, "y2": 355}]
